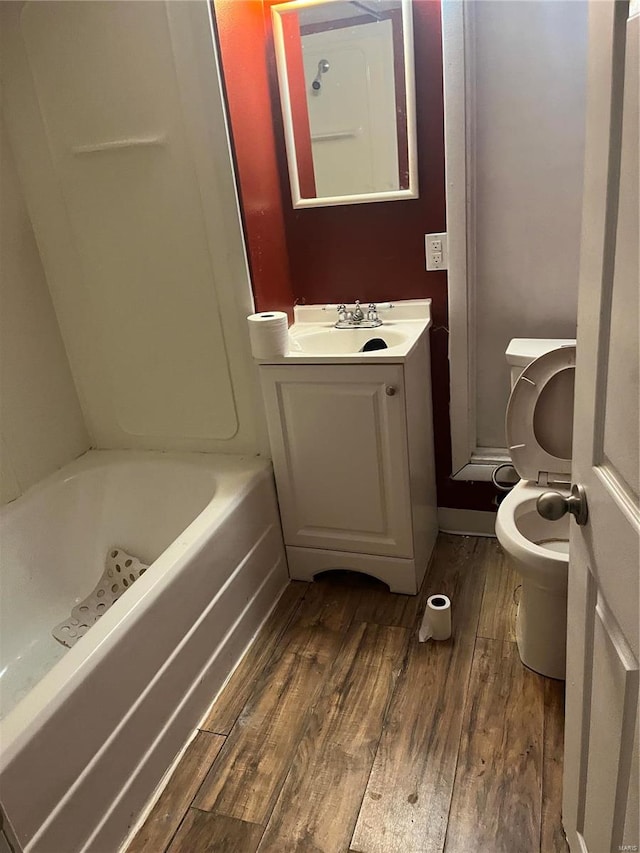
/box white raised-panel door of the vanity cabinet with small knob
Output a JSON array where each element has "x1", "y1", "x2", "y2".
[{"x1": 260, "y1": 364, "x2": 413, "y2": 557}]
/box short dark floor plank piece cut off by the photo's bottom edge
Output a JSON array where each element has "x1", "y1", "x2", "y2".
[{"x1": 168, "y1": 808, "x2": 264, "y2": 853}]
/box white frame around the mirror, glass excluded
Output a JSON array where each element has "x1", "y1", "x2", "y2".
[{"x1": 271, "y1": 0, "x2": 418, "y2": 208}]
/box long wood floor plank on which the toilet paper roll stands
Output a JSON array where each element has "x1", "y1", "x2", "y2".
[{"x1": 351, "y1": 536, "x2": 490, "y2": 853}]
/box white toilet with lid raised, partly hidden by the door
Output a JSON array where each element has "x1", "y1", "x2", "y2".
[{"x1": 496, "y1": 338, "x2": 576, "y2": 679}]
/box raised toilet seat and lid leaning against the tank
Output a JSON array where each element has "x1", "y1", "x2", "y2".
[{"x1": 506, "y1": 346, "x2": 576, "y2": 485}]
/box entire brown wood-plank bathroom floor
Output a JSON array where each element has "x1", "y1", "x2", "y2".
[{"x1": 128, "y1": 535, "x2": 568, "y2": 853}]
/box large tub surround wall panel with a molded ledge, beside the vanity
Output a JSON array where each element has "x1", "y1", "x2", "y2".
[{"x1": 0, "y1": 0, "x2": 258, "y2": 452}]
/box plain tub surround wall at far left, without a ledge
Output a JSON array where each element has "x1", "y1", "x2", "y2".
[{"x1": 0, "y1": 126, "x2": 89, "y2": 504}]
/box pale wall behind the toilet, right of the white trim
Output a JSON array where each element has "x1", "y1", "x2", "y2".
[{"x1": 470, "y1": 0, "x2": 587, "y2": 447}]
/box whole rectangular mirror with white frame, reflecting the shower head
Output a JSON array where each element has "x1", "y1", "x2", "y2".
[{"x1": 272, "y1": 0, "x2": 418, "y2": 207}]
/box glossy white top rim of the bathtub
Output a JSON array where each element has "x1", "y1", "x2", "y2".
[{"x1": 0, "y1": 450, "x2": 272, "y2": 776}]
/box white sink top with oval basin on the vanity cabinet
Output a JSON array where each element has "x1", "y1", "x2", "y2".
[{"x1": 258, "y1": 299, "x2": 431, "y2": 364}]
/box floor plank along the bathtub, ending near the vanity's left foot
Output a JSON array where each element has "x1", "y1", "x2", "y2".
[{"x1": 201, "y1": 581, "x2": 309, "y2": 735}]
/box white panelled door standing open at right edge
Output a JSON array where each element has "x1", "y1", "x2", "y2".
[{"x1": 563, "y1": 1, "x2": 640, "y2": 853}]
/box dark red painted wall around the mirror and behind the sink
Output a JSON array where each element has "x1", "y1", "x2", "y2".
[{"x1": 214, "y1": 0, "x2": 495, "y2": 510}]
